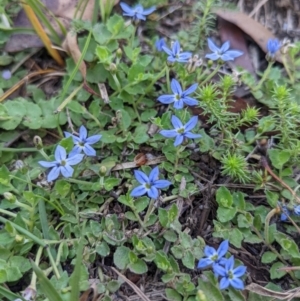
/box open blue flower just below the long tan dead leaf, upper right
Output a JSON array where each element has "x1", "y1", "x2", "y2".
[{"x1": 205, "y1": 39, "x2": 243, "y2": 62}]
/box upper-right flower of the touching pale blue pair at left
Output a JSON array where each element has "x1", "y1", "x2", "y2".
[{"x1": 64, "y1": 125, "x2": 102, "y2": 157}]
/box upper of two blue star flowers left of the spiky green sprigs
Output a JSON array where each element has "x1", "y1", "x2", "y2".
[{"x1": 157, "y1": 78, "x2": 198, "y2": 110}]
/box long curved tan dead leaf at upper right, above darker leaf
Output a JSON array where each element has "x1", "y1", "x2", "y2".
[{"x1": 214, "y1": 9, "x2": 282, "y2": 63}]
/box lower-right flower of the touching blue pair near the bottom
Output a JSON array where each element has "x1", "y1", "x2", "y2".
[{"x1": 215, "y1": 256, "x2": 247, "y2": 290}]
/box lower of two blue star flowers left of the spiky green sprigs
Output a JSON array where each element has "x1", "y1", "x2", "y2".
[{"x1": 159, "y1": 115, "x2": 202, "y2": 146}]
